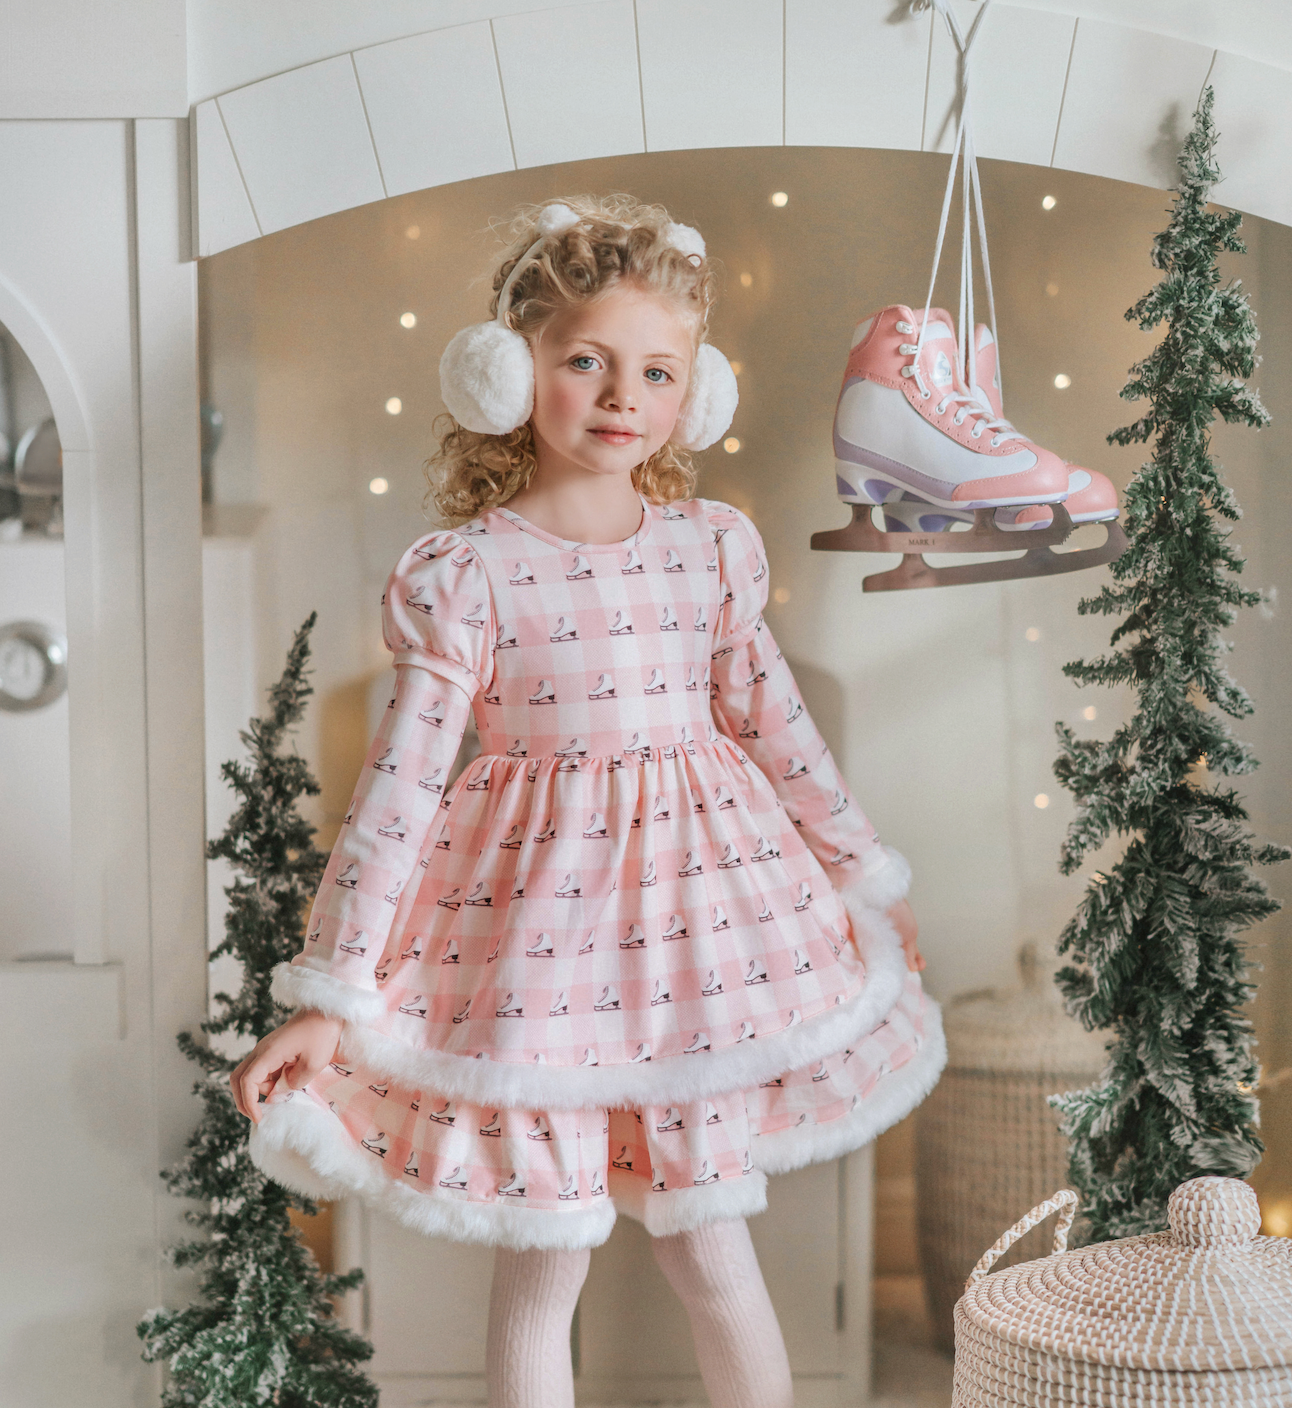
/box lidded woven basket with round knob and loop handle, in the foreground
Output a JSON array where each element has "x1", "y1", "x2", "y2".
[{"x1": 951, "y1": 1177, "x2": 1292, "y2": 1408}]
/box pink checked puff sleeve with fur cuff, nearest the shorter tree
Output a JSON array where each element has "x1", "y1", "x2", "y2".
[{"x1": 273, "y1": 532, "x2": 494, "y2": 1024}]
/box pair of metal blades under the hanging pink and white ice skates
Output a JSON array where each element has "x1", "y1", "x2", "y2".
[{"x1": 811, "y1": 504, "x2": 1126, "y2": 591}]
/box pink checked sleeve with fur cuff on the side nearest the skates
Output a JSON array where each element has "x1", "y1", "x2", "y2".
[{"x1": 705, "y1": 501, "x2": 911, "y2": 910}]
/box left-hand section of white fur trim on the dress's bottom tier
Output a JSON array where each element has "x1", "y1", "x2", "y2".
[{"x1": 249, "y1": 1093, "x2": 615, "y2": 1252}]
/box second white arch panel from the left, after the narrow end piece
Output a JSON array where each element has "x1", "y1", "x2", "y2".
[{"x1": 220, "y1": 54, "x2": 386, "y2": 234}]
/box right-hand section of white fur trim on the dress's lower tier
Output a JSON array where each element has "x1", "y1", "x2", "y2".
[{"x1": 753, "y1": 997, "x2": 947, "y2": 1173}]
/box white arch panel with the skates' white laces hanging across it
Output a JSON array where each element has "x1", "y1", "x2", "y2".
[{"x1": 923, "y1": 0, "x2": 1077, "y2": 166}]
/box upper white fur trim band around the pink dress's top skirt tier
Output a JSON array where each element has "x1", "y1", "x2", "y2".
[{"x1": 341, "y1": 910, "x2": 906, "y2": 1110}]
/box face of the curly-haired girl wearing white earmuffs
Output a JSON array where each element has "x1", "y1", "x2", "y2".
[{"x1": 531, "y1": 284, "x2": 694, "y2": 474}]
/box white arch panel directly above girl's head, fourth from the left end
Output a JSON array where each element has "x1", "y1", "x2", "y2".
[{"x1": 494, "y1": 0, "x2": 645, "y2": 166}]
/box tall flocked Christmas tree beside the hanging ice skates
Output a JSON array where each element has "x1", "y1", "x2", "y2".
[{"x1": 1053, "y1": 87, "x2": 1289, "y2": 1239}]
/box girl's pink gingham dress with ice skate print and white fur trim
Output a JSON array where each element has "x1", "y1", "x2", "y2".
[{"x1": 253, "y1": 498, "x2": 943, "y2": 1247}]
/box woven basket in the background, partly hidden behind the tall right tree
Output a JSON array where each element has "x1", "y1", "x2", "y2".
[{"x1": 915, "y1": 946, "x2": 1105, "y2": 1353}]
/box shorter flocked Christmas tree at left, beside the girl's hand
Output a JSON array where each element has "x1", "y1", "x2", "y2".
[{"x1": 139, "y1": 615, "x2": 377, "y2": 1408}]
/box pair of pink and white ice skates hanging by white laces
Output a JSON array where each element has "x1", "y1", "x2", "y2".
[{"x1": 811, "y1": 0, "x2": 1126, "y2": 591}]
